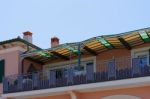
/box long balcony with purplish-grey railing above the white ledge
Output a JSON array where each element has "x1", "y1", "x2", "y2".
[{"x1": 3, "y1": 57, "x2": 150, "y2": 94}]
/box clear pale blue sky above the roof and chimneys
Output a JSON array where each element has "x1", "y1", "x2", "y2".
[{"x1": 0, "y1": 0, "x2": 150, "y2": 49}]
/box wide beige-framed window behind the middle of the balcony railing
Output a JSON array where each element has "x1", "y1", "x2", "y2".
[{"x1": 44, "y1": 59, "x2": 95, "y2": 79}]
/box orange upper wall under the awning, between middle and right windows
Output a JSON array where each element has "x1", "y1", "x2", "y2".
[{"x1": 96, "y1": 43, "x2": 150, "y2": 71}]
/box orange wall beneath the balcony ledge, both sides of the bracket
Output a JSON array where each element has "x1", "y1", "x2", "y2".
[{"x1": 22, "y1": 86, "x2": 150, "y2": 99}]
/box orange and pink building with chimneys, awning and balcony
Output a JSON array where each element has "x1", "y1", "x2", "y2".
[{"x1": 0, "y1": 28, "x2": 150, "y2": 99}]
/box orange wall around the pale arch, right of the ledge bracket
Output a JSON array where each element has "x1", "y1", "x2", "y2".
[{"x1": 80, "y1": 86, "x2": 150, "y2": 99}]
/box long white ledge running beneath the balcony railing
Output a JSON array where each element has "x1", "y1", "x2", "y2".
[{"x1": 2, "y1": 77, "x2": 150, "y2": 98}]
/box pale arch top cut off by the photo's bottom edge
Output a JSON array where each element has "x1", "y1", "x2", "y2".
[{"x1": 102, "y1": 95, "x2": 142, "y2": 99}]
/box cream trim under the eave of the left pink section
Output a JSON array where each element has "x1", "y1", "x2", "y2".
[{"x1": 0, "y1": 46, "x2": 26, "y2": 54}]
